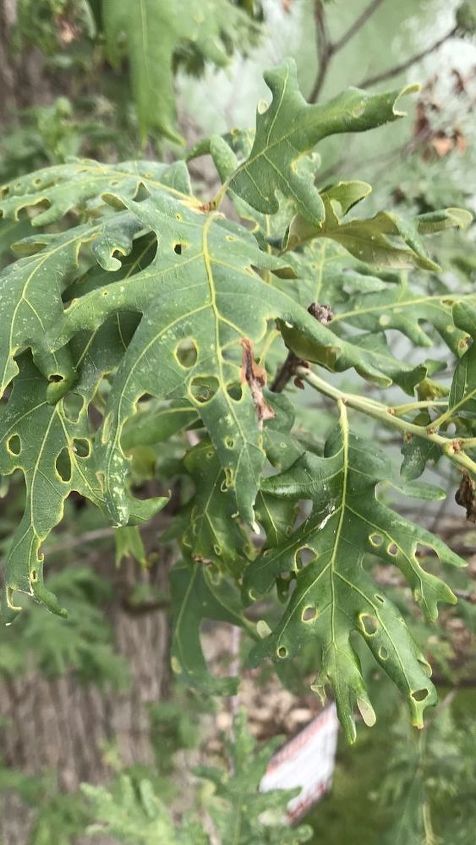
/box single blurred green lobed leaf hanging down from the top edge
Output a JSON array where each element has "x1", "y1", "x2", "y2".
[{"x1": 103, "y1": 0, "x2": 257, "y2": 141}]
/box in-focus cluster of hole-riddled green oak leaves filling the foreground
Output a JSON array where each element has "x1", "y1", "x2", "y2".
[{"x1": 0, "y1": 61, "x2": 476, "y2": 744}]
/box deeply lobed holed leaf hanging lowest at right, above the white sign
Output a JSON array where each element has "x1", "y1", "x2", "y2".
[{"x1": 244, "y1": 406, "x2": 463, "y2": 739}]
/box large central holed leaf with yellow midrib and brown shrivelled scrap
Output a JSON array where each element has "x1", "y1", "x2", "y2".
[{"x1": 48, "y1": 187, "x2": 398, "y2": 525}]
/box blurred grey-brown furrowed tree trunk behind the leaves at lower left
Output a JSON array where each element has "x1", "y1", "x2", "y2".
[{"x1": 0, "y1": 561, "x2": 169, "y2": 845}]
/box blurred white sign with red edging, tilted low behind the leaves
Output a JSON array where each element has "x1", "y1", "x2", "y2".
[{"x1": 260, "y1": 704, "x2": 339, "y2": 822}]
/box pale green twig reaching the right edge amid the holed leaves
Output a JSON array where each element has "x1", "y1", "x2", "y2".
[{"x1": 296, "y1": 367, "x2": 476, "y2": 474}]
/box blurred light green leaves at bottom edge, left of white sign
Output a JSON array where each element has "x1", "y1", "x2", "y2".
[{"x1": 83, "y1": 713, "x2": 310, "y2": 845}]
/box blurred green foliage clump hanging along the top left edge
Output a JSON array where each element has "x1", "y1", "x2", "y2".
[{"x1": 15, "y1": 0, "x2": 261, "y2": 143}]
